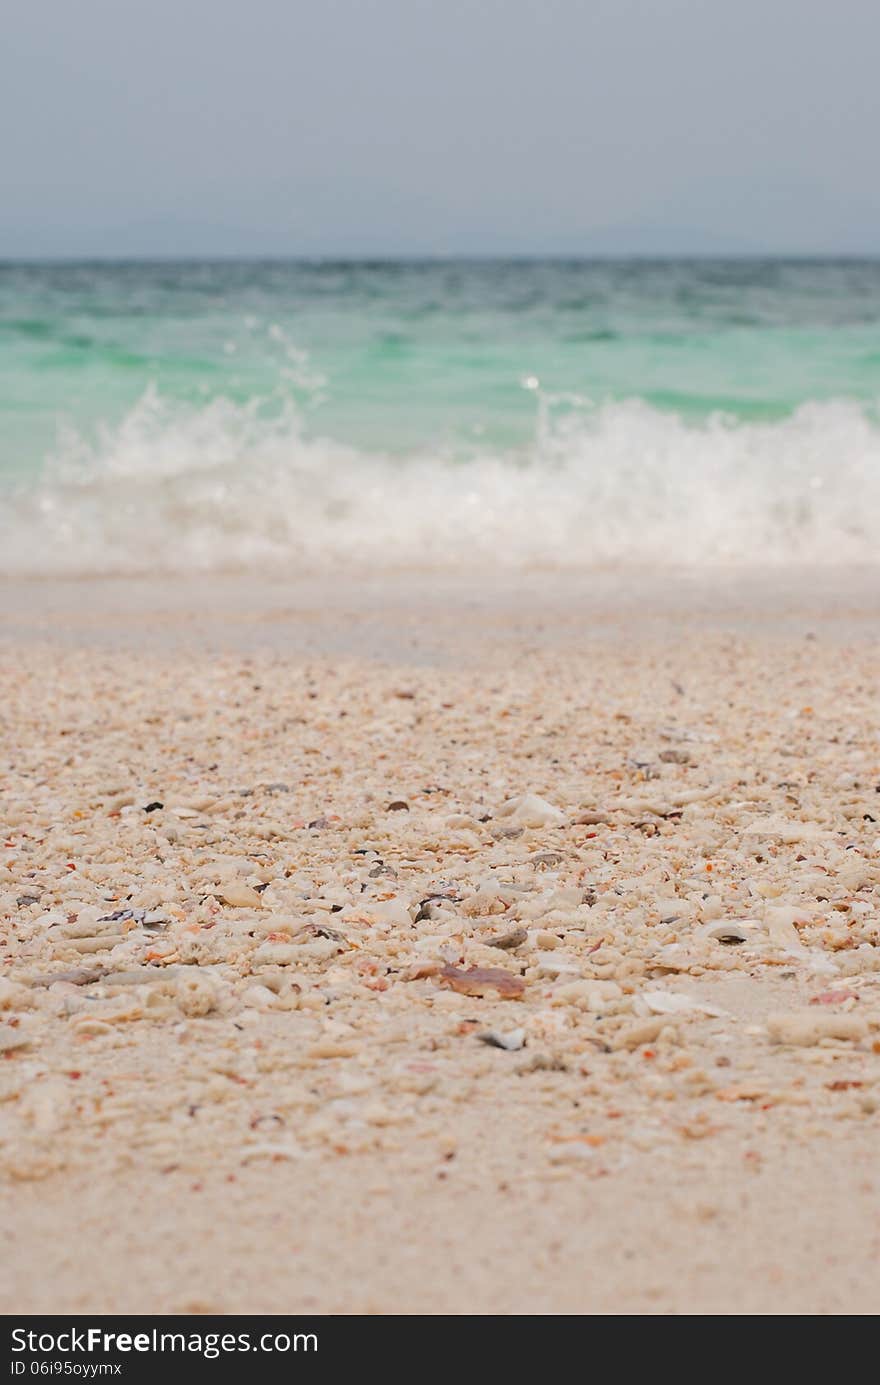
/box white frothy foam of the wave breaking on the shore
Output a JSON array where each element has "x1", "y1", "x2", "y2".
[{"x1": 0, "y1": 391, "x2": 880, "y2": 575}]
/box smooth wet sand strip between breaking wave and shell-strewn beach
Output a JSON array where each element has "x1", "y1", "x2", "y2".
[{"x1": 0, "y1": 562, "x2": 880, "y2": 642}]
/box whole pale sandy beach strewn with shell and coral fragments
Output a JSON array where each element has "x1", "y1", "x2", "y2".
[{"x1": 0, "y1": 568, "x2": 880, "y2": 1314}]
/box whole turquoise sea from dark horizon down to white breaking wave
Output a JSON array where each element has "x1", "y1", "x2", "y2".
[{"x1": 0, "y1": 260, "x2": 880, "y2": 571}]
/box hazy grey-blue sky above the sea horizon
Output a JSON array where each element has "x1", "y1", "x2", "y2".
[{"x1": 0, "y1": 0, "x2": 880, "y2": 258}]
